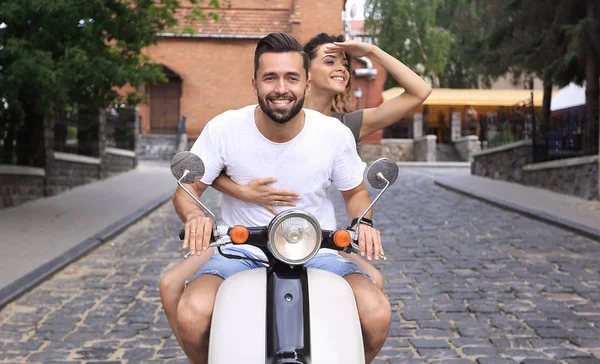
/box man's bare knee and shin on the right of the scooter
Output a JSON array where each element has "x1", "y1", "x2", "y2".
[{"x1": 344, "y1": 274, "x2": 392, "y2": 363}]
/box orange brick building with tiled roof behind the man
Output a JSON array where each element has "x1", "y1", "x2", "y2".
[{"x1": 139, "y1": 0, "x2": 345, "y2": 139}]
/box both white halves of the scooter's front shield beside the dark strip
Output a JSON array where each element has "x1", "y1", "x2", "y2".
[{"x1": 208, "y1": 269, "x2": 365, "y2": 364}]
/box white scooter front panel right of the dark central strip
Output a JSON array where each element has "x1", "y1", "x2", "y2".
[{"x1": 308, "y1": 269, "x2": 365, "y2": 364}]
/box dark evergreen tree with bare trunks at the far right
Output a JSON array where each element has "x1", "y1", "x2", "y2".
[{"x1": 479, "y1": 0, "x2": 600, "y2": 141}]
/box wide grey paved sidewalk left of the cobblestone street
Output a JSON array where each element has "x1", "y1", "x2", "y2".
[{"x1": 0, "y1": 162, "x2": 176, "y2": 308}]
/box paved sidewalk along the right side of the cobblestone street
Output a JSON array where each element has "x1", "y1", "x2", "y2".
[{"x1": 433, "y1": 174, "x2": 600, "y2": 241}]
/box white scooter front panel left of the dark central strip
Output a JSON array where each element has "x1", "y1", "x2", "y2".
[{"x1": 208, "y1": 269, "x2": 267, "y2": 364}]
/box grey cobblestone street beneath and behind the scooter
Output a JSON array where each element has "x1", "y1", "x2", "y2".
[{"x1": 0, "y1": 170, "x2": 600, "y2": 364}]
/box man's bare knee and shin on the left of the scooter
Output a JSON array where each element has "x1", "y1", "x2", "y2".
[{"x1": 177, "y1": 274, "x2": 223, "y2": 364}]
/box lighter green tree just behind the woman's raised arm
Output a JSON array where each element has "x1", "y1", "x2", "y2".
[{"x1": 366, "y1": 0, "x2": 503, "y2": 88}]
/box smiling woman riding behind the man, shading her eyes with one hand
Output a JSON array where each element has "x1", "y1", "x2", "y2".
[{"x1": 160, "y1": 33, "x2": 431, "y2": 356}]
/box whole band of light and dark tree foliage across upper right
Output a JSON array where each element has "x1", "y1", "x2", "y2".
[{"x1": 366, "y1": 0, "x2": 600, "y2": 91}]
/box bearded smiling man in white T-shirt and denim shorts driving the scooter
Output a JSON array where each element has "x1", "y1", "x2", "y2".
[{"x1": 173, "y1": 33, "x2": 391, "y2": 364}]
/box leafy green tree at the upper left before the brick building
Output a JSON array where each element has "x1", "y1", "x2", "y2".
[{"x1": 0, "y1": 0, "x2": 219, "y2": 165}]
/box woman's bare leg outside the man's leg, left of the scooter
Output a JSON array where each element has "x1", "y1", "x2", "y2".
[{"x1": 158, "y1": 248, "x2": 214, "y2": 349}]
